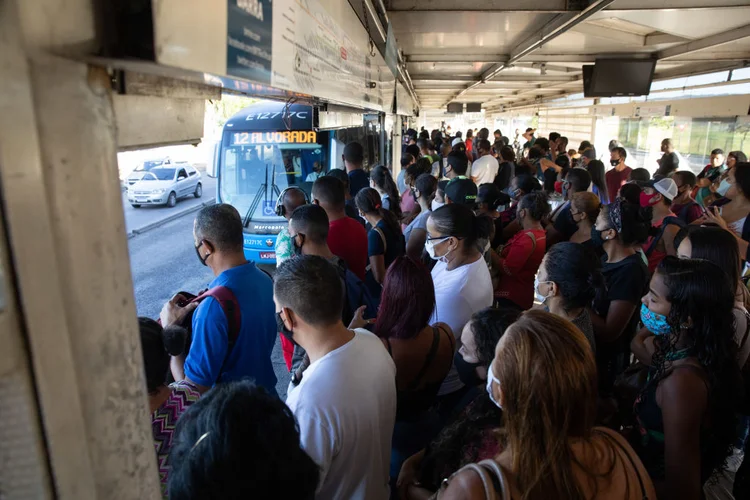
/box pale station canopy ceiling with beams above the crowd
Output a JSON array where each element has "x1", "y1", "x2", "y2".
[{"x1": 385, "y1": 0, "x2": 750, "y2": 111}]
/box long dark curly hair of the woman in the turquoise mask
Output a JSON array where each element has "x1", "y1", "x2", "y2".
[{"x1": 643, "y1": 256, "x2": 742, "y2": 480}]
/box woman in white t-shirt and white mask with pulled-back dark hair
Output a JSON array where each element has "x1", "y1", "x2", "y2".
[{"x1": 425, "y1": 204, "x2": 493, "y2": 415}]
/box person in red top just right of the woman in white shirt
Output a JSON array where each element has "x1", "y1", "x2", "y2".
[{"x1": 492, "y1": 192, "x2": 550, "y2": 310}]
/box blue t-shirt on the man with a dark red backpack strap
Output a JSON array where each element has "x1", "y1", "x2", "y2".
[{"x1": 185, "y1": 262, "x2": 276, "y2": 394}]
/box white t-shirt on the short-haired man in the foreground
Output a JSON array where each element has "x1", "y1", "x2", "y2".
[{"x1": 286, "y1": 329, "x2": 396, "y2": 500}]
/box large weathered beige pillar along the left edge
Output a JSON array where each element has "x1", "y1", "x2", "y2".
[{"x1": 0, "y1": 0, "x2": 160, "y2": 500}]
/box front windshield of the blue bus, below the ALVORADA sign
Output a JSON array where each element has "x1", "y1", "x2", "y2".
[{"x1": 219, "y1": 144, "x2": 326, "y2": 221}]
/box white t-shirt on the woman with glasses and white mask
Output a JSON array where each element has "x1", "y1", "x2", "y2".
[{"x1": 430, "y1": 258, "x2": 493, "y2": 396}]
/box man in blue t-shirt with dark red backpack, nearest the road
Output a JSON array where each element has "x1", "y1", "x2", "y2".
[{"x1": 161, "y1": 204, "x2": 277, "y2": 394}]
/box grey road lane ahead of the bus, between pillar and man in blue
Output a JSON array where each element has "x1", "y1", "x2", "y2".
[{"x1": 128, "y1": 209, "x2": 289, "y2": 397}]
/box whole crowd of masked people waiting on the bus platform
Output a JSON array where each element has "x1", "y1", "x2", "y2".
[{"x1": 140, "y1": 128, "x2": 750, "y2": 500}]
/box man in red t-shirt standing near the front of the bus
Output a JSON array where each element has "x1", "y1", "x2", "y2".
[{"x1": 312, "y1": 176, "x2": 367, "y2": 281}]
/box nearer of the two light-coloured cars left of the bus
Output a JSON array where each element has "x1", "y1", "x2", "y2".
[{"x1": 128, "y1": 163, "x2": 203, "y2": 208}]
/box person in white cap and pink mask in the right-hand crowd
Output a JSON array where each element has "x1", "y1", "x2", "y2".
[{"x1": 641, "y1": 177, "x2": 681, "y2": 273}]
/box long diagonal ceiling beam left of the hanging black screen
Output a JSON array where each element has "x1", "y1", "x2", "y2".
[{"x1": 446, "y1": 0, "x2": 615, "y2": 104}]
